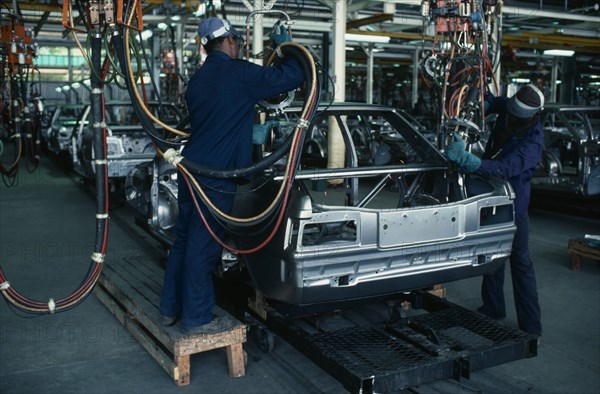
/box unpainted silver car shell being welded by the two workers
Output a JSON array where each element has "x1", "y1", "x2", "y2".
[{"x1": 127, "y1": 103, "x2": 515, "y2": 306}]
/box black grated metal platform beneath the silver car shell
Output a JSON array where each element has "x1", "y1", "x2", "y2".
[{"x1": 267, "y1": 292, "x2": 537, "y2": 393}]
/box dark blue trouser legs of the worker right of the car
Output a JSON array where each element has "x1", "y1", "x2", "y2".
[{"x1": 481, "y1": 214, "x2": 542, "y2": 335}]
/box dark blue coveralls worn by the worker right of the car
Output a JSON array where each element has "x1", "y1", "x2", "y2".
[{"x1": 477, "y1": 97, "x2": 544, "y2": 335}]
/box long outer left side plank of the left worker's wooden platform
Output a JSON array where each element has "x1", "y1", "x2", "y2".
[{"x1": 94, "y1": 286, "x2": 180, "y2": 381}]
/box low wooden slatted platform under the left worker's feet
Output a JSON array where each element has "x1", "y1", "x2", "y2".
[{"x1": 94, "y1": 254, "x2": 246, "y2": 386}]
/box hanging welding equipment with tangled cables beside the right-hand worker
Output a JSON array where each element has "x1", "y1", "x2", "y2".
[{"x1": 421, "y1": 0, "x2": 502, "y2": 148}]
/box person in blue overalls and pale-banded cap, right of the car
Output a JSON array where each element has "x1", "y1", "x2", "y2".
[{"x1": 445, "y1": 85, "x2": 544, "y2": 336}]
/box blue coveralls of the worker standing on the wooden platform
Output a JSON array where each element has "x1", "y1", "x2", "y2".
[{"x1": 160, "y1": 51, "x2": 304, "y2": 328}]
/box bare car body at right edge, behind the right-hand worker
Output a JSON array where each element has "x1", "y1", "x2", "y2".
[{"x1": 531, "y1": 104, "x2": 600, "y2": 198}]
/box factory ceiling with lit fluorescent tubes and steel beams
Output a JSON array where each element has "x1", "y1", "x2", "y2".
[{"x1": 2, "y1": 0, "x2": 600, "y2": 73}]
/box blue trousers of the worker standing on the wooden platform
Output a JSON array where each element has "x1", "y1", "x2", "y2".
[{"x1": 160, "y1": 174, "x2": 233, "y2": 328}]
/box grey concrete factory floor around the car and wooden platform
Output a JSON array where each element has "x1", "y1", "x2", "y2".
[{"x1": 0, "y1": 158, "x2": 600, "y2": 394}]
